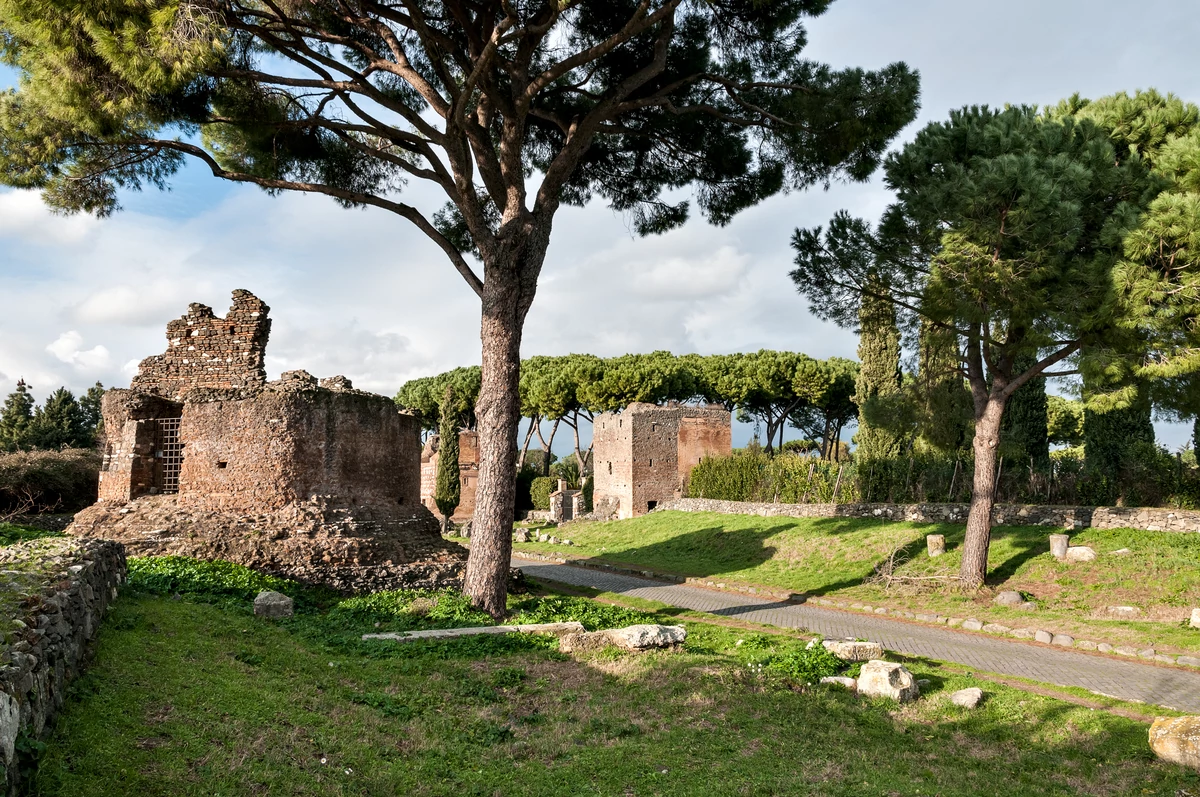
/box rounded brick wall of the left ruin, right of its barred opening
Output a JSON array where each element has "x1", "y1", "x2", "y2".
[{"x1": 179, "y1": 380, "x2": 420, "y2": 513}]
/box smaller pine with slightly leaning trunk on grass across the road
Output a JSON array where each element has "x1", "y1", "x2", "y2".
[{"x1": 793, "y1": 107, "x2": 1168, "y2": 588}]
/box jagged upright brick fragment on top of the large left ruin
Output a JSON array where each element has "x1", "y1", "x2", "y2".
[{"x1": 131, "y1": 290, "x2": 271, "y2": 397}]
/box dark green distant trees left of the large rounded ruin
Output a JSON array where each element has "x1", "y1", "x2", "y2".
[{"x1": 0, "y1": 379, "x2": 104, "y2": 453}]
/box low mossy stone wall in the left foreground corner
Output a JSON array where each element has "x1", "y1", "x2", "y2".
[{"x1": 0, "y1": 538, "x2": 125, "y2": 795}]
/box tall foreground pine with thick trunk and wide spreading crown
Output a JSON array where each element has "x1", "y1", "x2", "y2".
[{"x1": 0, "y1": 0, "x2": 918, "y2": 617}]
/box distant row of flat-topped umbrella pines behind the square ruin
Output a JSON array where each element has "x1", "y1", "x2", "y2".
[{"x1": 396, "y1": 349, "x2": 858, "y2": 474}]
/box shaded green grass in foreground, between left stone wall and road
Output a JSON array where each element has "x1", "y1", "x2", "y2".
[{"x1": 34, "y1": 566, "x2": 1200, "y2": 797}]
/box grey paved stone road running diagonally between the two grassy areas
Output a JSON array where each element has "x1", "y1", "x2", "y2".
[{"x1": 512, "y1": 557, "x2": 1200, "y2": 712}]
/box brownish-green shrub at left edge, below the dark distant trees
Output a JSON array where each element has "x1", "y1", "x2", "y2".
[{"x1": 0, "y1": 449, "x2": 102, "y2": 513}]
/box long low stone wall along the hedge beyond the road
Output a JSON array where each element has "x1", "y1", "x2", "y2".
[{"x1": 654, "y1": 498, "x2": 1200, "y2": 533}]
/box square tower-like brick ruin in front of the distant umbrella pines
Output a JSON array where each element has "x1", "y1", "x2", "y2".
[{"x1": 592, "y1": 403, "x2": 731, "y2": 519}]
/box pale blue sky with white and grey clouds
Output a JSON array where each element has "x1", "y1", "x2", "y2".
[{"x1": 0, "y1": 0, "x2": 1200, "y2": 450}]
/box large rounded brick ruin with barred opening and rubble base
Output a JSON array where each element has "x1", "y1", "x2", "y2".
[{"x1": 68, "y1": 290, "x2": 464, "y2": 592}]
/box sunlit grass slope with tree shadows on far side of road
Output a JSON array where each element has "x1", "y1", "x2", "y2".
[{"x1": 515, "y1": 513, "x2": 1200, "y2": 653}]
